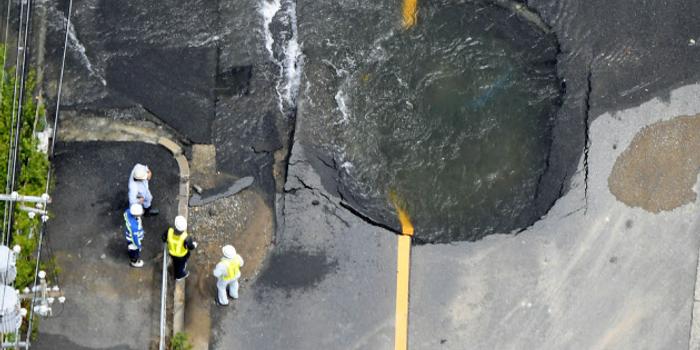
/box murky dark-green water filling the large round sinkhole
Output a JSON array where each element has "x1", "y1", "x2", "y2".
[{"x1": 298, "y1": 1, "x2": 561, "y2": 242}]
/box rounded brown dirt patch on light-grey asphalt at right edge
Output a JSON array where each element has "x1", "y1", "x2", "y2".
[{"x1": 608, "y1": 114, "x2": 700, "y2": 213}]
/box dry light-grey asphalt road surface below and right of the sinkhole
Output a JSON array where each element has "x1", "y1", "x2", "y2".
[{"x1": 221, "y1": 80, "x2": 700, "y2": 349}]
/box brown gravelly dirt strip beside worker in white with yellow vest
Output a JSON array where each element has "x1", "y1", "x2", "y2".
[{"x1": 185, "y1": 190, "x2": 274, "y2": 349}]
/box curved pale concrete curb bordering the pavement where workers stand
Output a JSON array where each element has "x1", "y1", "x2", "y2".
[{"x1": 58, "y1": 118, "x2": 190, "y2": 344}]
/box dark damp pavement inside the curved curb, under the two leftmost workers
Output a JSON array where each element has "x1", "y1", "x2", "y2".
[{"x1": 32, "y1": 142, "x2": 179, "y2": 350}]
